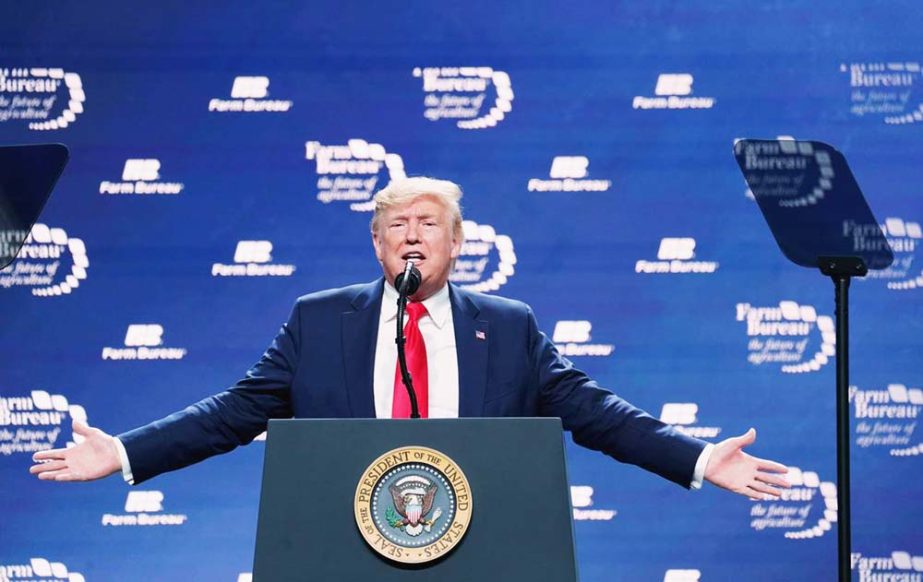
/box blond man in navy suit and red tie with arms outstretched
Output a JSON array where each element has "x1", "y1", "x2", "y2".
[{"x1": 30, "y1": 178, "x2": 788, "y2": 499}]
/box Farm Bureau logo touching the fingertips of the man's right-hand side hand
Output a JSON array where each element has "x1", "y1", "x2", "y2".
[{"x1": 750, "y1": 467, "x2": 837, "y2": 540}]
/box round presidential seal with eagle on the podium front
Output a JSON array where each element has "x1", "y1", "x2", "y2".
[{"x1": 354, "y1": 446, "x2": 472, "y2": 564}]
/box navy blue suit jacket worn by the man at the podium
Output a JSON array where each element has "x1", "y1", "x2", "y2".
[{"x1": 119, "y1": 279, "x2": 705, "y2": 487}]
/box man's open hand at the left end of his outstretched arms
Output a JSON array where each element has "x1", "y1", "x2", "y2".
[{"x1": 29, "y1": 420, "x2": 122, "y2": 481}]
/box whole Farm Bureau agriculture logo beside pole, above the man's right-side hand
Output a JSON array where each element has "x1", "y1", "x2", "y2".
[{"x1": 737, "y1": 301, "x2": 836, "y2": 374}]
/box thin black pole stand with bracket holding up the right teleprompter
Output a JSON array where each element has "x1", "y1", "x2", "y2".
[{"x1": 818, "y1": 257, "x2": 868, "y2": 582}]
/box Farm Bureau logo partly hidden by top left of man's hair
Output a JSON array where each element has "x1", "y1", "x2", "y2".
[{"x1": 304, "y1": 139, "x2": 407, "y2": 212}]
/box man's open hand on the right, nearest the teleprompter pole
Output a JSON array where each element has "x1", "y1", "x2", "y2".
[{"x1": 705, "y1": 428, "x2": 791, "y2": 501}]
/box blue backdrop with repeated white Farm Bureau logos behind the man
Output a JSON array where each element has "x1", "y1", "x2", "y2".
[{"x1": 0, "y1": 0, "x2": 923, "y2": 582}]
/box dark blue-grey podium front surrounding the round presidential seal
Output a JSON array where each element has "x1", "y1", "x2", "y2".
[{"x1": 253, "y1": 418, "x2": 577, "y2": 582}]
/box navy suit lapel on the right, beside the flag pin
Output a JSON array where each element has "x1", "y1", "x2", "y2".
[{"x1": 449, "y1": 285, "x2": 490, "y2": 417}]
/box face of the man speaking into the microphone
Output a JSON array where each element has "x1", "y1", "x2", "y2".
[{"x1": 372, "y1": 194, "x2": 461, "y2": 301}]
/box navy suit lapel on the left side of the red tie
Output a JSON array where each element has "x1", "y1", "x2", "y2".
[{"x1": 340, "y1": 279, "x2": 384, "y2": 418}]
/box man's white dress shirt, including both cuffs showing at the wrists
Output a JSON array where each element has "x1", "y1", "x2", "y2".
[{"x1": 114, "y1": 282, "x2": 715, "y2": 489}]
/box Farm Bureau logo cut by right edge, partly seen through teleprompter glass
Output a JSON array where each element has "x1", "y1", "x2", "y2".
[{"x1": 860, "y1": 217, "x2": 923, "y2": 291}]
